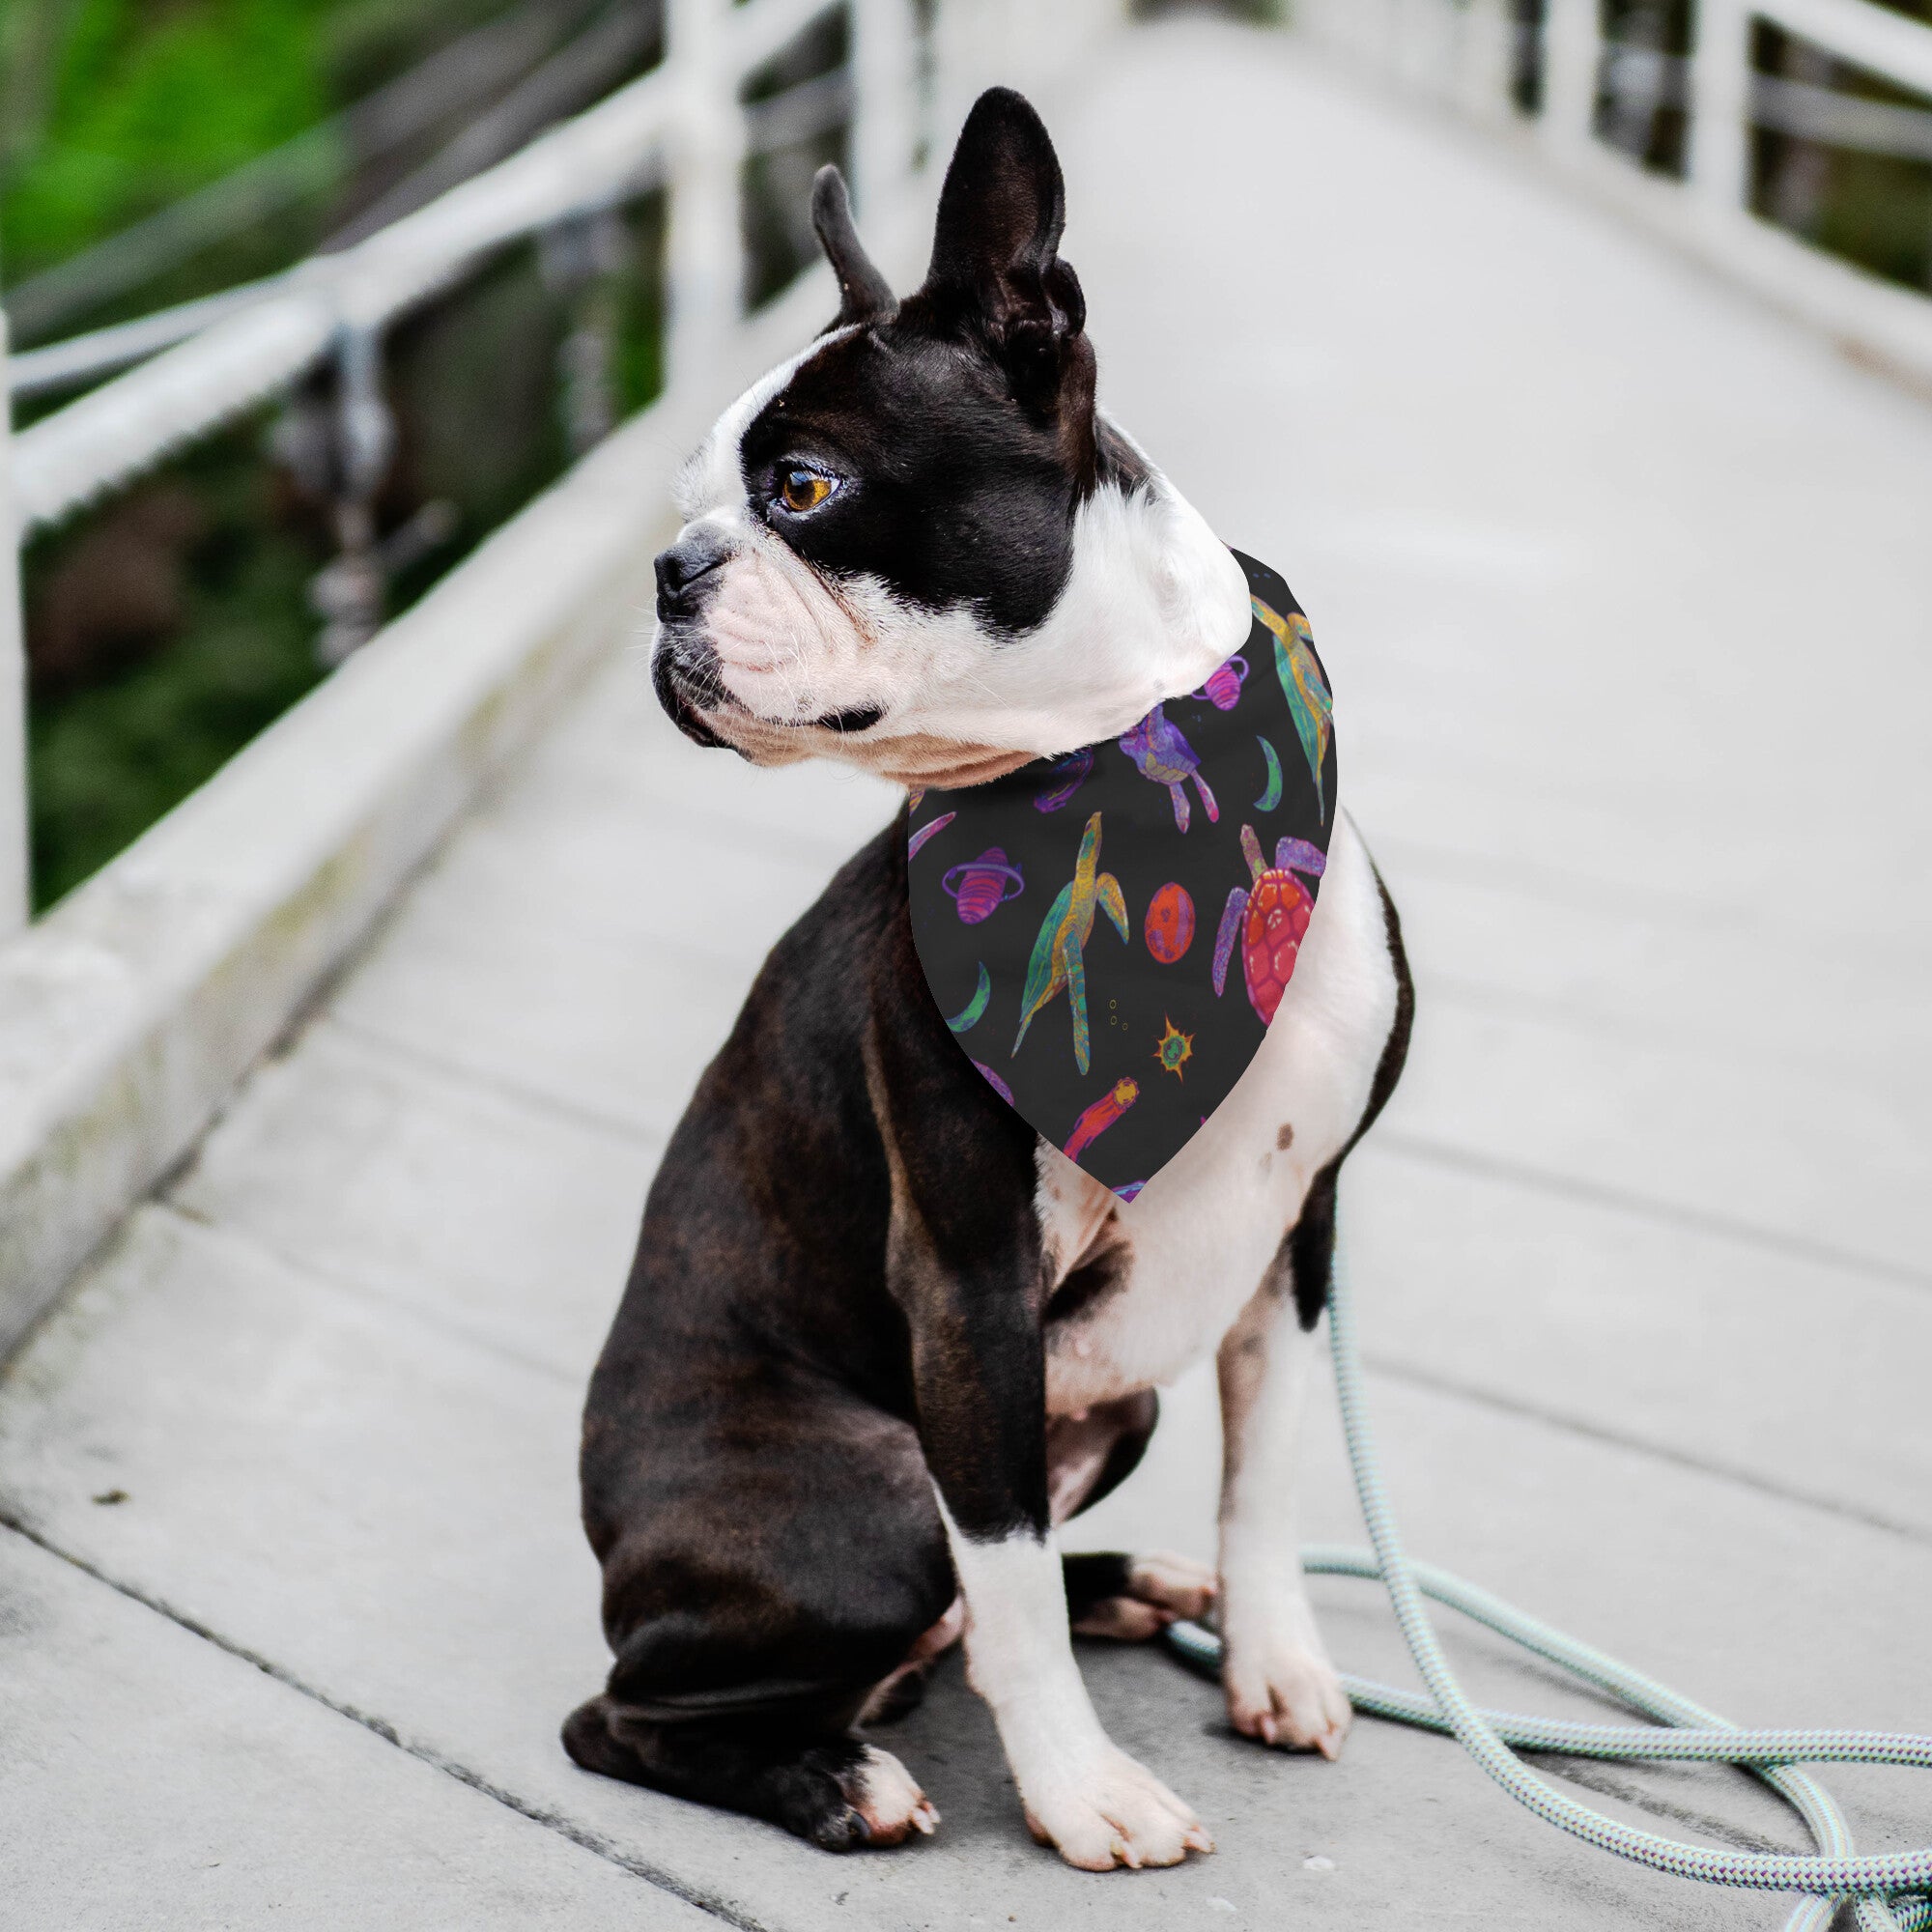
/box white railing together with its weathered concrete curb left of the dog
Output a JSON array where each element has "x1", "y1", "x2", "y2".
[{"x1": 0, "y1": 0, "x2": 1124, "y2": 1356}]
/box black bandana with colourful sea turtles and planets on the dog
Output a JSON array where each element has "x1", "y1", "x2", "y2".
[{"x1": 906, "y1": 551, "x2": 1335, "y2": 1200}]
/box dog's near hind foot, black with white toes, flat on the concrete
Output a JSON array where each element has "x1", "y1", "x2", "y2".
[{"x1": 564, "y1": 1694, "x2": 939, "y2": 1851}]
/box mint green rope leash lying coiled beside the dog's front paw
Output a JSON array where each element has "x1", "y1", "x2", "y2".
[{"x1": 1167, "y1": 1206, "x2": 1932, "y2": 1932}]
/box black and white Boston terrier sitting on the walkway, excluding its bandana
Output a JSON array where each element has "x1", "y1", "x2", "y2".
[{"x1": 564, "y1": 91, "x2": 1410, "y2": 1870}]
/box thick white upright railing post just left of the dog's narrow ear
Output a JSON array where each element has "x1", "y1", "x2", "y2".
[{"x1": 665, "y1": 0, "x2": 744, "y2": 392}]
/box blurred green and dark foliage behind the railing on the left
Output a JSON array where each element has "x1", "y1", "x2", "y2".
[{"x1": 0, "y1": 0, "x2": 663, "y2": 906}]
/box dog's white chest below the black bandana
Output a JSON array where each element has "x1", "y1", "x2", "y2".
[{"x1": 1036, "y1": 817, "x2": 1397, "y2": 1414}]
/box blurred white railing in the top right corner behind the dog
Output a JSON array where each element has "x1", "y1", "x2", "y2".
[{"x1": 1293, "y1": 0, "x2": 1932, "y2": 388}]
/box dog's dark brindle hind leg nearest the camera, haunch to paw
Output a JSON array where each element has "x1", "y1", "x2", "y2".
[{"x1": 564, "y1": 1362, "x2": 954, "y2": 1851}]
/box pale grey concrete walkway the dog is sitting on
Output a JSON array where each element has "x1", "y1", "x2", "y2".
[{"x1": 0, "y1": 23, "x2": 1932, "y2": 1932}]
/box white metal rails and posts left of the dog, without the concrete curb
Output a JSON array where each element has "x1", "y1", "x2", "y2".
[{"x1": 0, "y1": 0, "x2": 981, "y2": 939}]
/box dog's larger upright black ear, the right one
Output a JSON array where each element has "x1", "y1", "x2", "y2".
[{"x1": 923, "y1": 87, "x2": 1086, "y2": 404}]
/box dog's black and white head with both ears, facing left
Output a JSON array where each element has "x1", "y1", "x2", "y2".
[{"x1": 653, "y1": 89, "x2": 1248, "y2": 784}]
